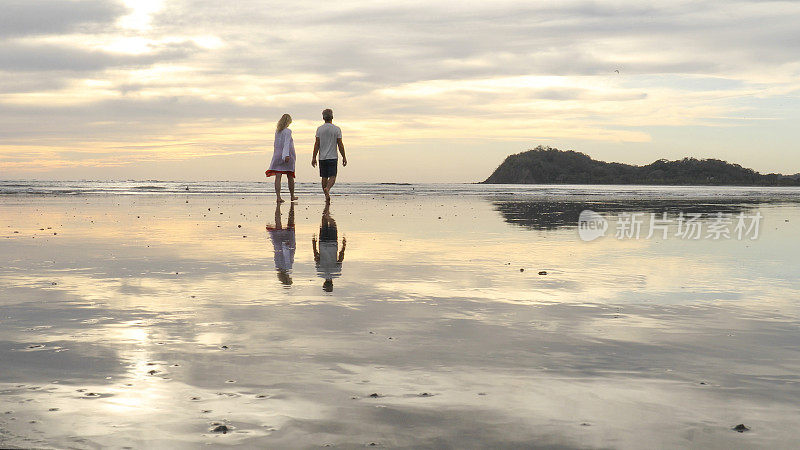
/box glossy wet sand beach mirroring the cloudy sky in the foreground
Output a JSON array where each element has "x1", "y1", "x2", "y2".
[{"x1": 0, "y1": 195, "x2": 800, "y2": 448}]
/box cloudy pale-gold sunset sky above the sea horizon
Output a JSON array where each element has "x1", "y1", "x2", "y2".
[{"x1": 0, "y1": 0, "x2": 800, "y2": 182}]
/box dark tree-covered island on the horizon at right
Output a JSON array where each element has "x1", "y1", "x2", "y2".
[{"x1": 483, "y1": 146, "x2": 800, "y2": 186}]
